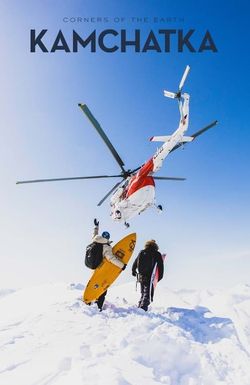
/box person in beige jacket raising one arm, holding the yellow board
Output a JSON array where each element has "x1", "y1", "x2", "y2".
[{"x1": 87, "y1": 218, "x2": 127, "y2": 311}]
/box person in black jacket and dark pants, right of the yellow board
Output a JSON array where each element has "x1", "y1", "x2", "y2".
[{"x1": 132, "y1": 240, "x2": 164, "y2": 311}]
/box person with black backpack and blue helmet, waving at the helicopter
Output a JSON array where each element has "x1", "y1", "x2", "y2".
[{"x1": 85, "y1": 218, "x2": 127, "y2": 311}]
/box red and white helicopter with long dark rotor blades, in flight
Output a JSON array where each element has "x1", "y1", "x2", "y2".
[{"x1": 17, "y1": 66, "x2": 217, "y2": 227}]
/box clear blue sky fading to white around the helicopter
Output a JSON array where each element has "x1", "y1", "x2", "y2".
[{"x1": 0, "y1": 0, "x2": 250, "y2": 288}]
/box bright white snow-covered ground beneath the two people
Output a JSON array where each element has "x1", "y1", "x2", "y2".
[{"x1": 0, "y1": 281, "x2": 250, "y2": 385}]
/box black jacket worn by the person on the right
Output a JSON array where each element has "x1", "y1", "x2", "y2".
[{"x1": 132, "y1": 247, "x2": 164, "y2": 281}]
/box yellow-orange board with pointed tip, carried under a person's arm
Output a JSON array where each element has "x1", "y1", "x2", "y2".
[{"x1": 83, "y1": 233, "x2": 136, "y2": 303}]
